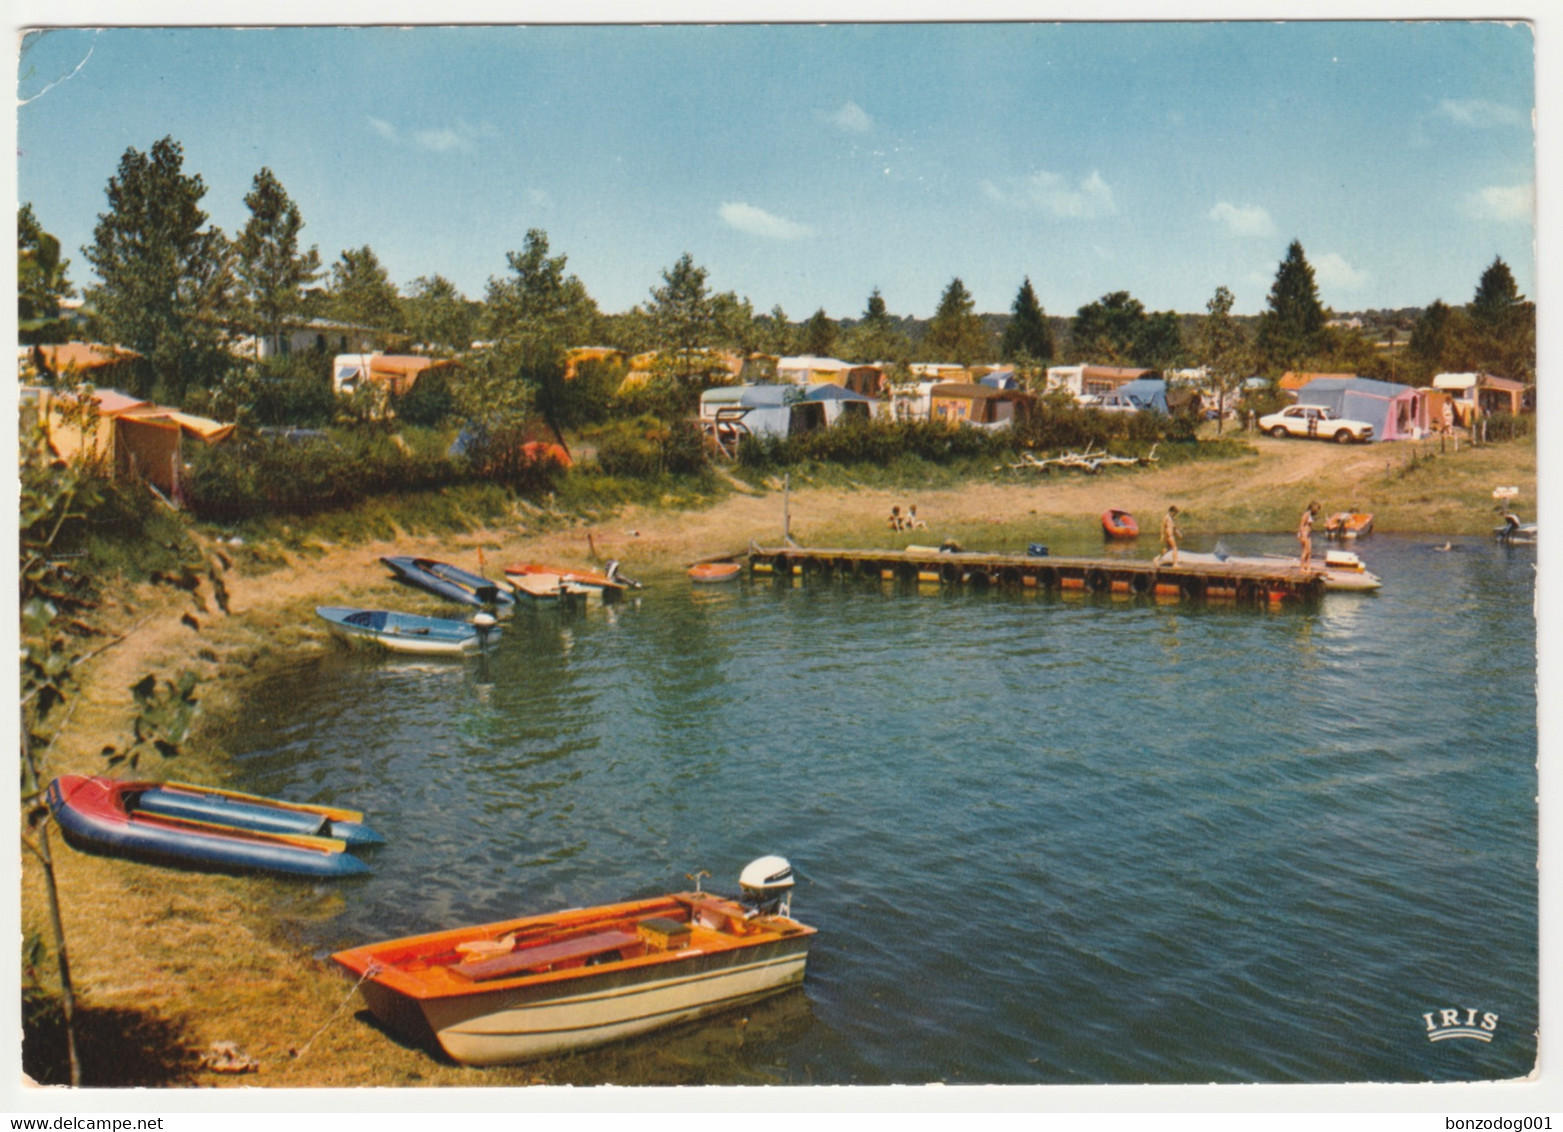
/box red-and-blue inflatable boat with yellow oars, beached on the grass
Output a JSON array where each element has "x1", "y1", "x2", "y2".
[{"x1": 47, "y1": 774, "x2": 384, "y2": 877}]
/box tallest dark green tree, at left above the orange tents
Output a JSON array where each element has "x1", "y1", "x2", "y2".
[{"x1": 83, "y1": 138, "x2": 233, "y2": 402}]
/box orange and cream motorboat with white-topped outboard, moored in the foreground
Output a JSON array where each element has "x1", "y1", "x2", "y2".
[{"x1": 331, "y1": 857, "x2": 814, "y2": 1065}]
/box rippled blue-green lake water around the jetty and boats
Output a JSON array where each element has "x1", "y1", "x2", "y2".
[{"x1": 222, "y1": 535, "x2": 1538, "y2": 1084}]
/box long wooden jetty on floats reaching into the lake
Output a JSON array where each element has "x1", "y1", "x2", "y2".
[{"x1": 749, "y1": 546, "x2": 1324, "y2": 605}]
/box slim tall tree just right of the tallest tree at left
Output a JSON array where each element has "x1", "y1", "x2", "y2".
[{"x1": 233, "y1": 167, "x2": 320, "y2": 353}]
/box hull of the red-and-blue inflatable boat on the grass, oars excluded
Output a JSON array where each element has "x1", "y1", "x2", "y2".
[{"x1": 47, "y1": 774, "x2": 381, "y2": 877}]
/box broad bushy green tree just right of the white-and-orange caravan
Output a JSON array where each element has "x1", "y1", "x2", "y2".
[{"x1": 463, "y1": 228, "x2": 599, "y2": 436}]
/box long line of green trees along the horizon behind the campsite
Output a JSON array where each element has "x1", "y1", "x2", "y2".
[{"x1": 17, "y1": 138, "x2": 1535, "y2": 421}]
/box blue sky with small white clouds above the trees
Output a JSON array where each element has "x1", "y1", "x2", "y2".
[{"x1": 17, "y1": 22, "x2": 1536, "y2": 319}]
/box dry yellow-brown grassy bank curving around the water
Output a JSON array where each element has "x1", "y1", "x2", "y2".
[{"x1": 22, "y1": 438, "x2": 1536, "y2": 1087}]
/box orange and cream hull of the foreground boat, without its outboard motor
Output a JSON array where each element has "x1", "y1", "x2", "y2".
[{"x1": 333, "y1": 893, "x2": 814, "y2": 1065}]
